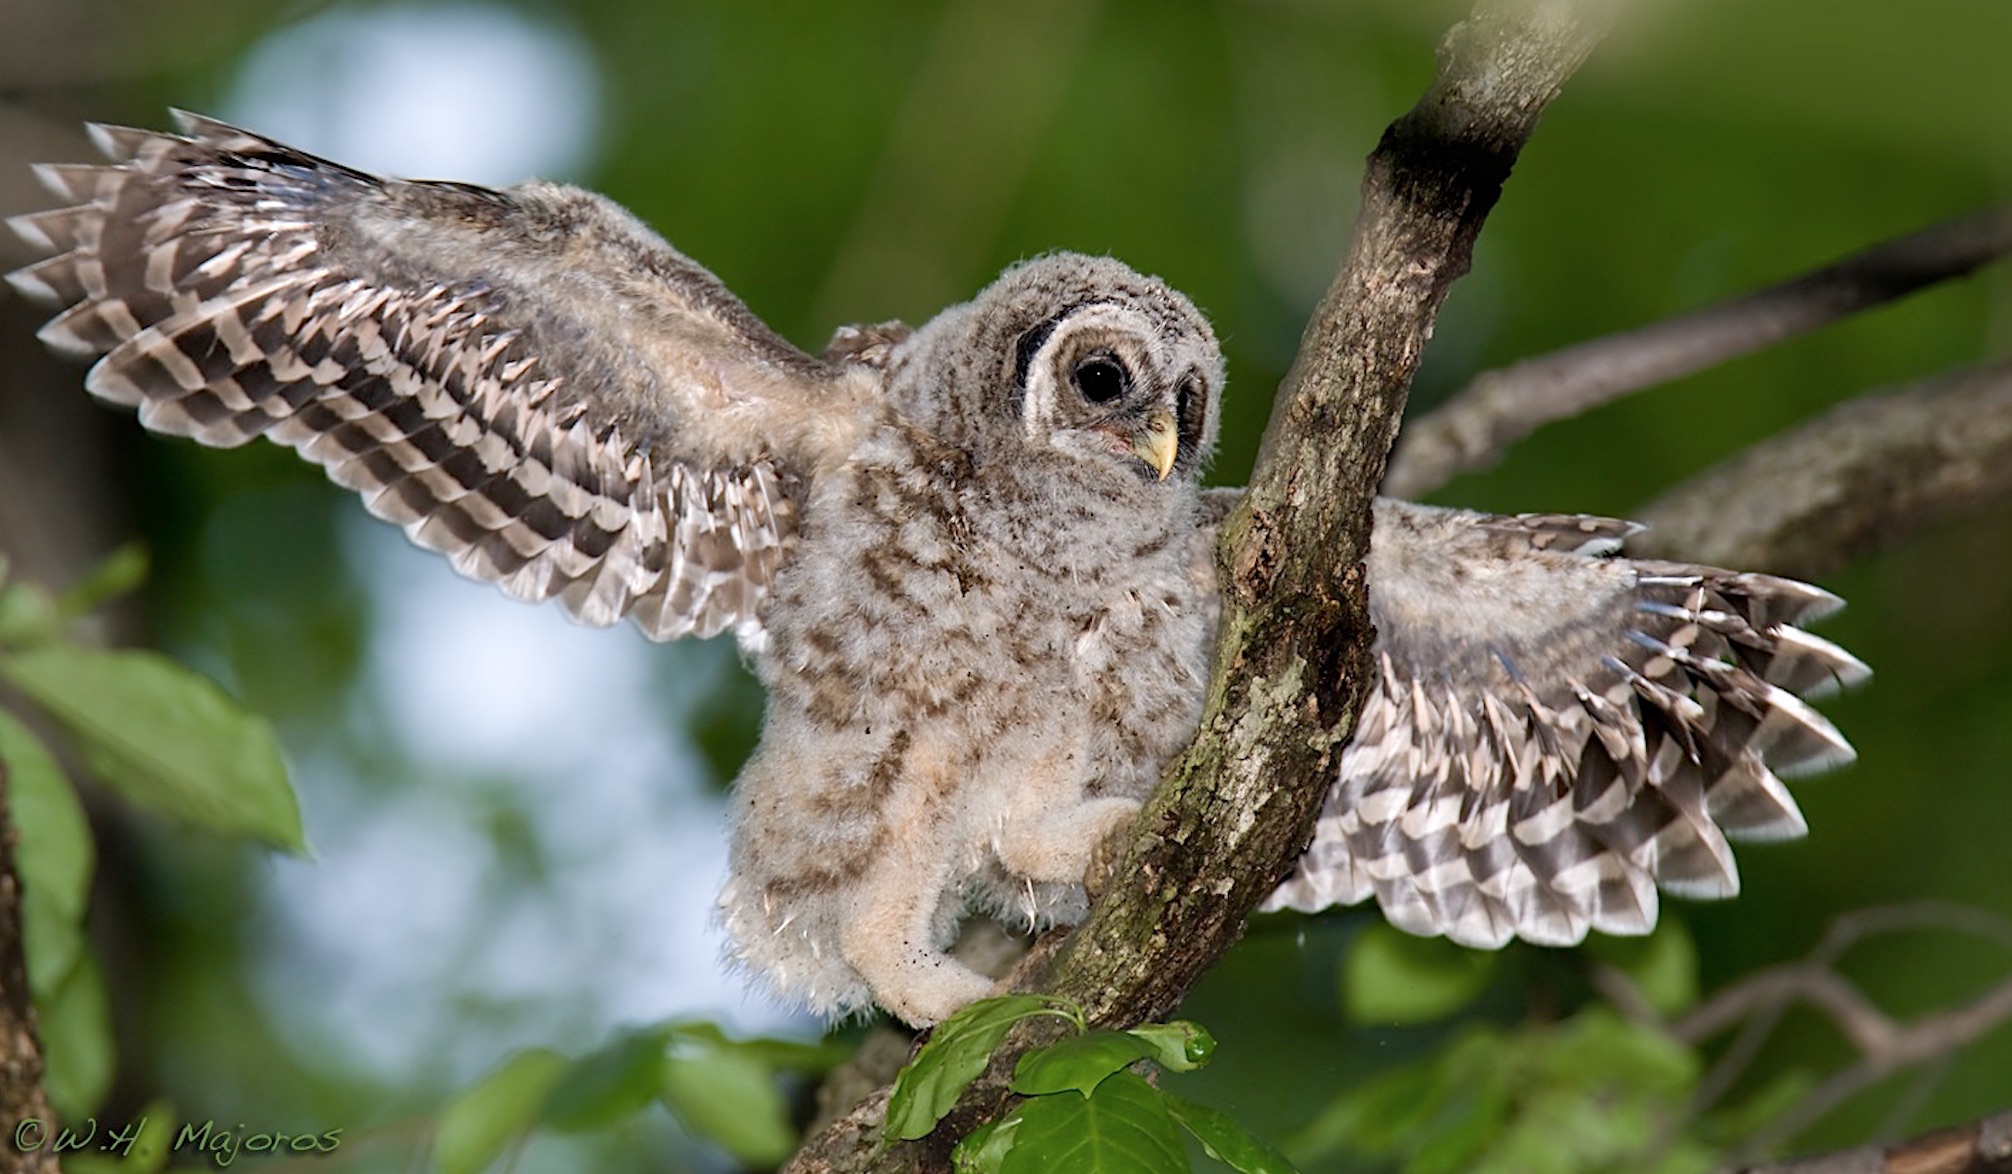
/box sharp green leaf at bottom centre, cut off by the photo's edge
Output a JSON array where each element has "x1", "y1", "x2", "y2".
[{"x1": 1000, "y1": 1071, "x2": 1189, "y2": 1174}]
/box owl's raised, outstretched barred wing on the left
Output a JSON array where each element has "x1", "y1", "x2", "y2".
[{"x1": 10, "y1": 113, "x2": 879, "y2": 638}]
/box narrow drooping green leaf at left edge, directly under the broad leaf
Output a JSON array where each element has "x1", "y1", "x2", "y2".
[{"x1": 0, "y1": 711, "x2": 95, "y2": 999}]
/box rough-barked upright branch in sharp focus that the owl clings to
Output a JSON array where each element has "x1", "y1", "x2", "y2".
[{"x1": 791, "y1": 0, "x2": 1612, "y2": 1170}]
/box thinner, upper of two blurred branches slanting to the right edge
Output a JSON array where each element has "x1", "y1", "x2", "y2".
[{"x1": 1384, "y1": 207, "x2": 2012, "y2": 497}]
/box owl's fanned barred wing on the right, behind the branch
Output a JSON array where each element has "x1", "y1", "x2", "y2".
[{"x1": 1266, "y1": 499, "x2": 1867, "y2": 946}]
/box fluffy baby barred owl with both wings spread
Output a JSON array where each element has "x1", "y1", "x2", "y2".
[{"x1": 12, "y1": 115, "x2": 1865, "y2": 1025}]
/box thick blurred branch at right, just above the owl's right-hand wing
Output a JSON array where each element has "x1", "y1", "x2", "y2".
[{"x1": 1630, "y1": 362, "x2": 2012, "y2": 578}]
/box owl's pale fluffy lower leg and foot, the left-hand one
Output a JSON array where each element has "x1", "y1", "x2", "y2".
[{"x1": 839, "y1": 846, "x2": 994, "y2": 1027}]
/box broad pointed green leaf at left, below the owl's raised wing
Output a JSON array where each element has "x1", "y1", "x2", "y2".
[{"x1": 0, "y1": 646, "x2": 306, "y2": 852}]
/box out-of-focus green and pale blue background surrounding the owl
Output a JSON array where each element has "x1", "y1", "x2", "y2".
[{"x1": 0, "y1": 0, "x2": 2012, "y2": 1170}]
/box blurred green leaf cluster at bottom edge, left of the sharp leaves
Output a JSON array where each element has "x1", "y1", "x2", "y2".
[{"x1": 433, "y1": 1023, "x2": 843, "y2": 1174}]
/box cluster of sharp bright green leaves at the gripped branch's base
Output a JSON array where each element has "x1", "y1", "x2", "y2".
[{"x1": 887, "y1": 995, "x2": 1292, "y2": 1174}]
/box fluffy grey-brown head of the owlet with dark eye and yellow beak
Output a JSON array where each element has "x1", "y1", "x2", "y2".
[{"x1": 903, "y1": 254, "x2": 1223, "y2": 485}]
